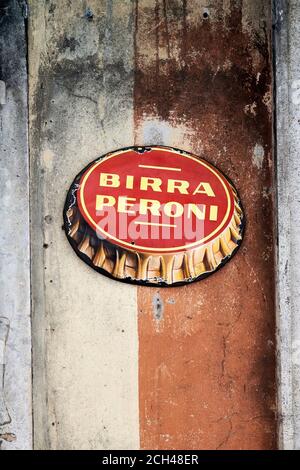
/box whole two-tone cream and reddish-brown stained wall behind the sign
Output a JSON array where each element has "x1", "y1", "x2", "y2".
[{"x1": 28, "y1": 0, "x2": 276, "y2": 449}]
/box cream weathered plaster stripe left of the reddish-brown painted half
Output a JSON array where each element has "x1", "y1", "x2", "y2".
[{"x1": 29, "y1": 0, "x2": 139, "y2": 449}]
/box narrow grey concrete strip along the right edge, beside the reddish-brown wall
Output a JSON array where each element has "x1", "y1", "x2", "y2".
[{"x1": 274, "y1": 0, "x2": 300, "y2": 450}]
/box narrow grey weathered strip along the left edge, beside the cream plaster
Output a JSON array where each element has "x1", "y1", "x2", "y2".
[{"x1": 0, "y1": 0, "x2": 32, "y2": 449}]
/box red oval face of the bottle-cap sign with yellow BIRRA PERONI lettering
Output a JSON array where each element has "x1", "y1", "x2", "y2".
[{"x1": 78, "y1": 147, "x2": 234, "y2": 253}]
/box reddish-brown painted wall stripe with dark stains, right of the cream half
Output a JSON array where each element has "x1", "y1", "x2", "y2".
[{"x1": 134, "y1": 0, "x2": 276, "y2": 449}]
